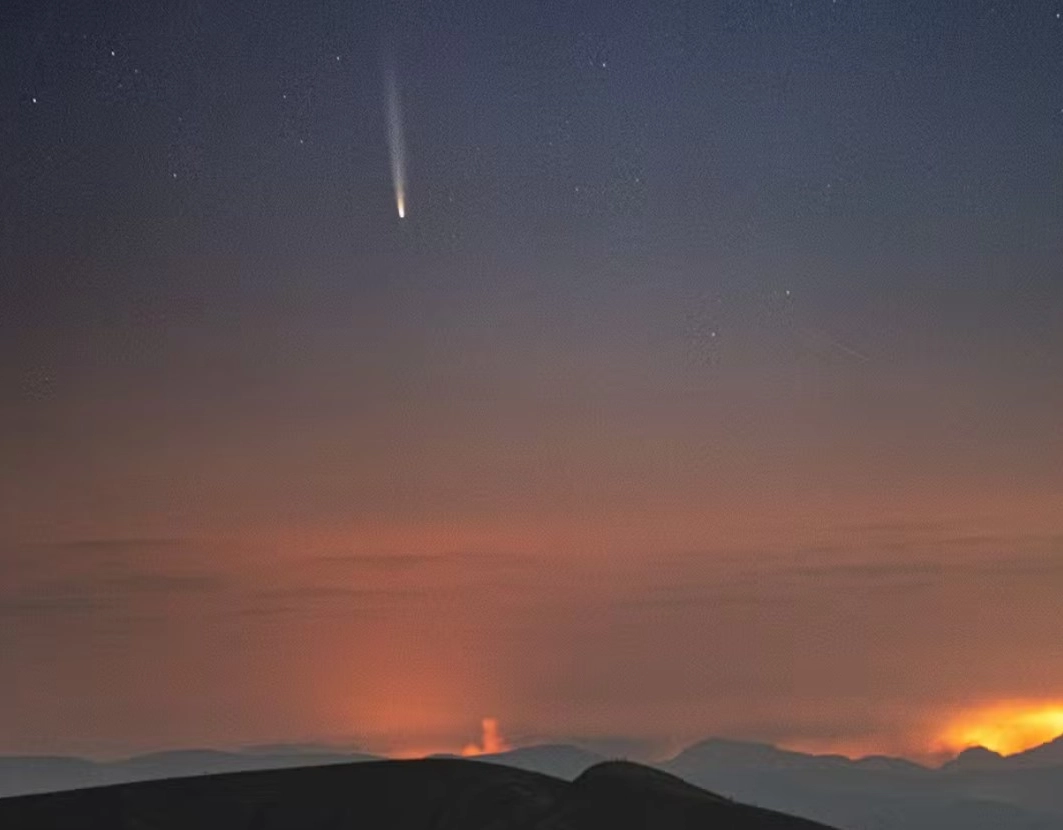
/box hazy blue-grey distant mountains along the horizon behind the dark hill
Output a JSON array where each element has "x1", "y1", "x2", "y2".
[{"x1": 0, "y1": 738, "x2": 1063, "y2": 830}]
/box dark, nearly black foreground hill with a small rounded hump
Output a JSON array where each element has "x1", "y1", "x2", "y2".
[{"x1": 0, "y1": 759, "x2": 824, "y2": 830}]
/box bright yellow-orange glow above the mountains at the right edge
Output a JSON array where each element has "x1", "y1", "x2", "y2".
[{"x1": 941, "y1": 702, "x2": 1063, "y2": 755}]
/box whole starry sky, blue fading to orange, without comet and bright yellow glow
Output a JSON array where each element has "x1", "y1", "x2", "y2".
[{"x1": 0, "y1": 0, "x2": 1063, "y2": 758}]
